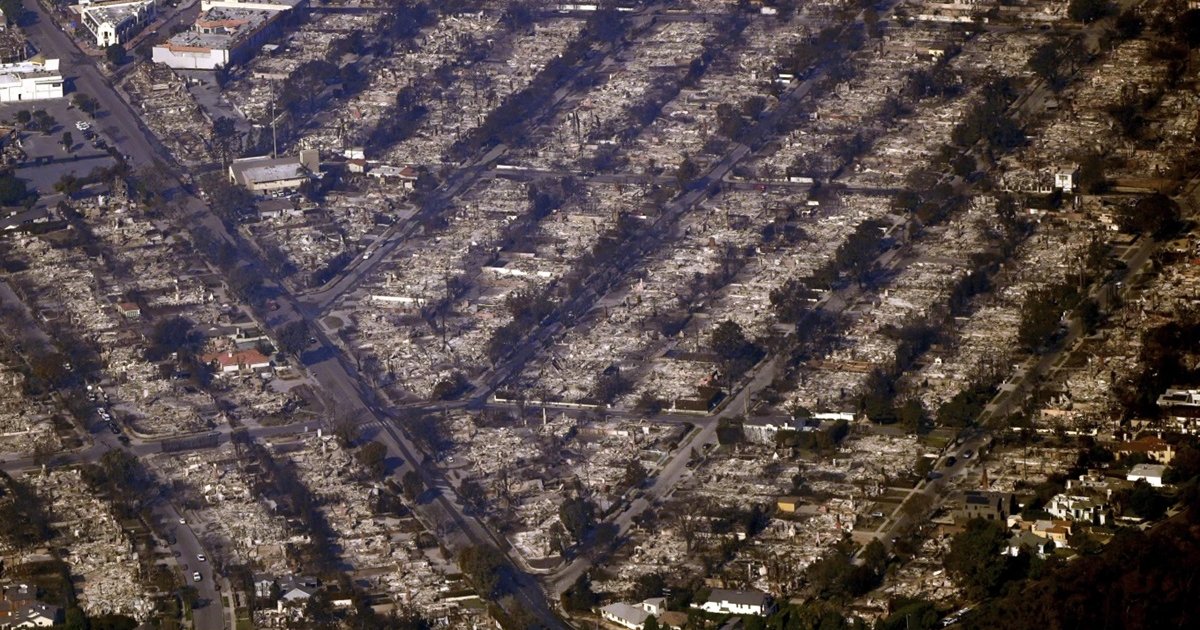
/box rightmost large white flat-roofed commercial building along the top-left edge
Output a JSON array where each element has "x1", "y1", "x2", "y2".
[{"x1": 152, "y1": 0, "x2": 306, "y2": 70}]
